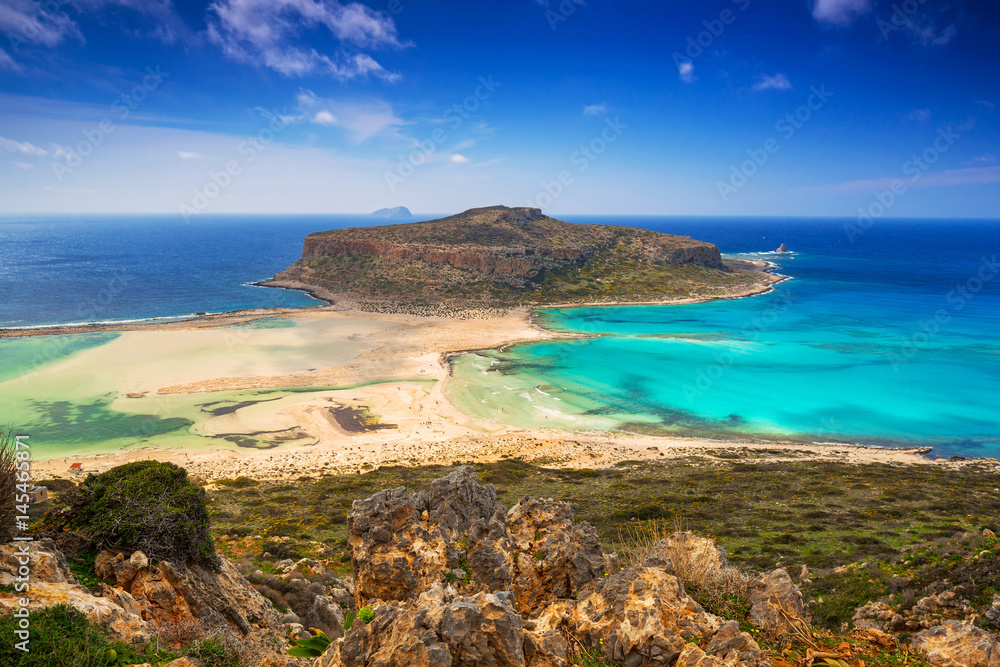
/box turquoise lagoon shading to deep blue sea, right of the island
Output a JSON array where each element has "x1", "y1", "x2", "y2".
[{"x1": 456, "y1": 221, "x2": 1000, "y2": 457}]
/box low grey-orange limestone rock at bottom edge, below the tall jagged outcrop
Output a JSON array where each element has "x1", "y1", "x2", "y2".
[{"x1": 315, "y1": 588, "x2": 525, "y2": 667}]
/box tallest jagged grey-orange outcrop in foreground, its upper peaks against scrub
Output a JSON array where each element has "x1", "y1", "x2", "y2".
[{"x1": 347, "y1": 467, "x2": 605, "y2": 612}]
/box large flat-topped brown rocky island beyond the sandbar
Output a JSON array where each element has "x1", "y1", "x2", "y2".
[{"x1": 260, "y1": 206, "x2": 779, "y2": 311}]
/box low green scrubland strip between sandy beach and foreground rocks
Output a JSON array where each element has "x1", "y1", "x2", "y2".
[{"x1": 209, "y1": 460, "x2": 1000, "y2": 570}]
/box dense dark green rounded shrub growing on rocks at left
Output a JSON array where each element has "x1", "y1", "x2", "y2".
[{"x1": 49, "y1": 461, "x2": 218, "y2": 567}]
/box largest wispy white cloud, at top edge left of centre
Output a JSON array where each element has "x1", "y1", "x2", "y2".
[{"x1": 208, "y1": 0, "x2": 405, "y2": 81}]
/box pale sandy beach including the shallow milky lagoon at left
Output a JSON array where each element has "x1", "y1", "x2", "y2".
[{"x1": 5, "y1": 290, "x2": 992, "y2": 482}]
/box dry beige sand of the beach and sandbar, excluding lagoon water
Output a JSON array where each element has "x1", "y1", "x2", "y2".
[{"x1": 13, "y1": 262, "x2": 990, "y2": 480}]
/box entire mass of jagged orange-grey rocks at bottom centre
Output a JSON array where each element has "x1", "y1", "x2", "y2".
[{"x1": 317, "y1": 467, "x2": 772, "y2": 667}]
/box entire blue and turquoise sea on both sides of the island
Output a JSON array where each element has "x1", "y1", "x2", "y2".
[{"x1": 0, "y1": 215, "x2": 1000, "y2": 458}]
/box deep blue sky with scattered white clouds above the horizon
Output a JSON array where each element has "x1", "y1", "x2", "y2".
[{"x1": 0, "y1": 0, "x2": 1000, "y2": 218}]
